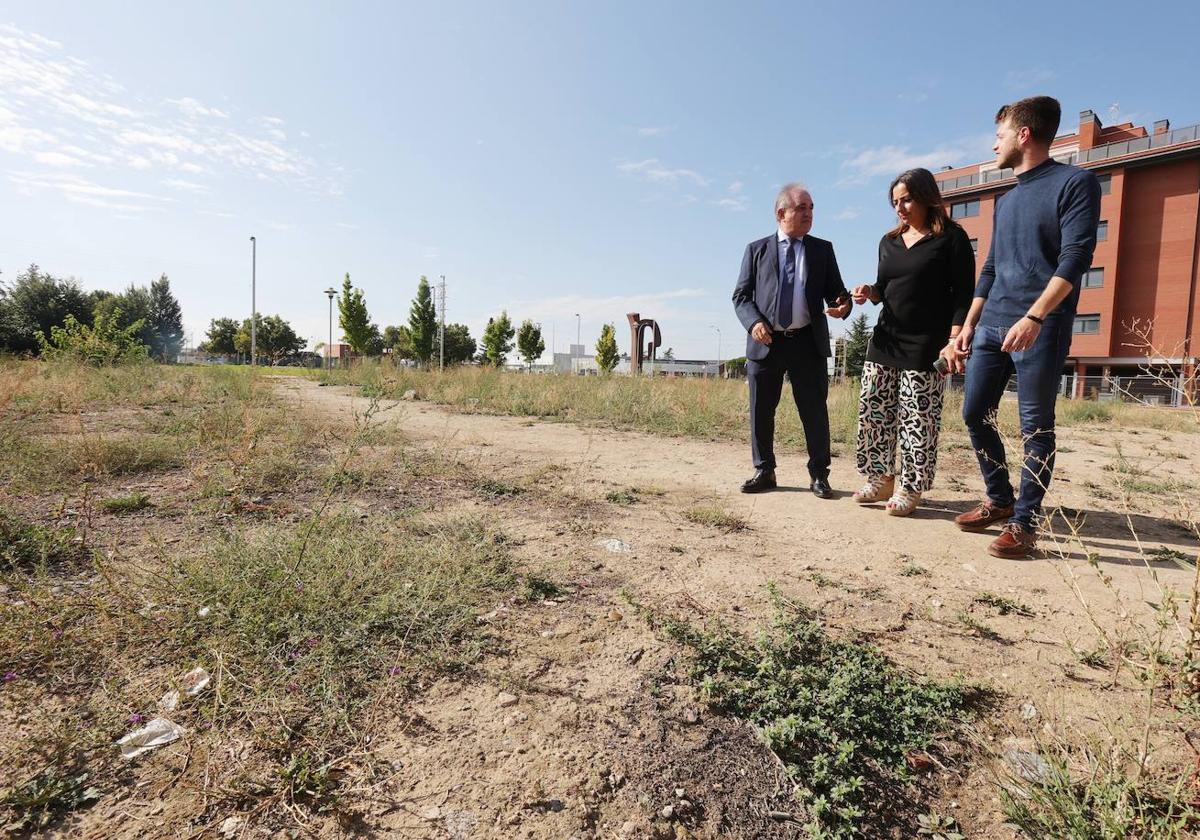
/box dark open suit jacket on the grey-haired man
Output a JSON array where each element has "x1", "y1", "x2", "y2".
[{"x1": 733, "y1": 233, "x2": 850, "y2": 361}]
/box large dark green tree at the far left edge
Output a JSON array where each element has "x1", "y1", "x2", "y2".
[{"x1": 0, "y1": 264, "x2": 92, "y2": 353}]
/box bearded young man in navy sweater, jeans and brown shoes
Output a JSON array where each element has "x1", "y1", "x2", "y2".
[{"x1": 947, "y1": 96, "x2": 1100, "y2": 558}]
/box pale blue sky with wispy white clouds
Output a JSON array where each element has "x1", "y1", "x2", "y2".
[{"x1": 0, "y1": 0, "x2": 1200, "y2": 358}]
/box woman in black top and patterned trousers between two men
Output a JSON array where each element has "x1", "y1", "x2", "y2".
[{"x1": 851, "y1": 169, "x2": 976, "y2": 516}]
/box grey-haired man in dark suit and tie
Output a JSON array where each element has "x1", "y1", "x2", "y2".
[{"x1": 733, "y1": 184, "x2": 853, "y2": 499}]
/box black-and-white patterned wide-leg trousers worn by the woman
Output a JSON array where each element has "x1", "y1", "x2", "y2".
[{"x1": 854, "y1": 361, "x2": 946, "y2": 493}]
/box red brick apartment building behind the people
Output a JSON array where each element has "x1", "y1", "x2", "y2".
[{"x1": 936, "y1": 110, "x2": 1200, "y2": 403}]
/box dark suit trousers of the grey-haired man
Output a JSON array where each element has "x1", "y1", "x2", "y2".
[{"x1": 746, "y1": 326, "x2": 830, "y2": 478}]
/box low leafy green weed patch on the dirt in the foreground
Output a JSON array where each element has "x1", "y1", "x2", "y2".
[{"x1": 635, "y1": 594, "x2": 968, "y2": 840}]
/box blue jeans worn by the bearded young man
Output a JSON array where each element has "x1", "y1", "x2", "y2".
[{"x1": 962, "y1": 318, "x2": 1072, "y2": 530}]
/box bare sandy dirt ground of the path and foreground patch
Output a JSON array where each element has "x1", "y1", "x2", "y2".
[{"x1": 258, "y1": 379, "x2": 1200, "y2": 839}]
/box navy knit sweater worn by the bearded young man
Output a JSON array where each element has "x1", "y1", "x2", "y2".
[{"x1": 974, "y1": 160, "x2": 1100, "y2": 329}]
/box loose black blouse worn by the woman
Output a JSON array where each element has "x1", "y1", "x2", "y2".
[{"x1": 866, "y1": 224, "x2": 976, "y2": 371}]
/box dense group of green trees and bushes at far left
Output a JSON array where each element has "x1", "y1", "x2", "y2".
[{"x1": 0, "y1": 264, "x2": 184, "y2": 361}]
